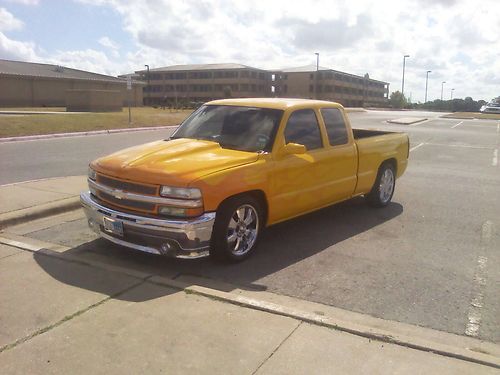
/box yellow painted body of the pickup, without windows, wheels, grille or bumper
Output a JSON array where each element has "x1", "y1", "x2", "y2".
[{"x1": 91, "y1": 98, "x2": 408, "y2": 225}]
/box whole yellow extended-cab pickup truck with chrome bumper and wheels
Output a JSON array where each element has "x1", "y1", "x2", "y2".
[{"x1": 80, "y1": 98, "x2": 409, "y2": 261}]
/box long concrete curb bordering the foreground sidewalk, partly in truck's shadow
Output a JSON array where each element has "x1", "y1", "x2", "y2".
[{"x1": 0, "y1": 233, "x2": 500, "y2": 369}]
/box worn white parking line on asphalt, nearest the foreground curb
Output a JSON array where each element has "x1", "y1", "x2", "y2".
[{"x1": 465, "y1": 220, "x2": 493, "y2": 337}]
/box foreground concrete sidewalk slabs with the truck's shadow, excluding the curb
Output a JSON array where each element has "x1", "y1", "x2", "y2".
[{"x1": 0, "y1": 245, "x2": 498, "y2": 374}]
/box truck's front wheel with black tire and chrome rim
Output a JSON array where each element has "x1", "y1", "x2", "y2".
[{"x1": 210, "y1": 196, "x2": 264, "y2": 262}]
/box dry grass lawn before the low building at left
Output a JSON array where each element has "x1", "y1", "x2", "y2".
[{"x1": 0, "y1": 107, "x2": 192, "y2": 138}]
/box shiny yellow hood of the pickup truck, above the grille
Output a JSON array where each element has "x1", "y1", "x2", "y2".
[{"x1": 91, "y1": 138, "x2": 258, "y2": 187}]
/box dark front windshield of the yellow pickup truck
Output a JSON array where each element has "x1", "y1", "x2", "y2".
[{"x1": 170, "y1": 105, "x2": 283, "y2": 152}]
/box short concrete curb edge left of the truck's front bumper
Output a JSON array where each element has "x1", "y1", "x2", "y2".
[{"x1": 0, "y1": 197, "x2": 81, "y2": 229}]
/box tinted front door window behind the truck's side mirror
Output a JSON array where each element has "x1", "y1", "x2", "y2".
[{"x1": 285, "y1": 109, "x2": 323, "y2": 151}]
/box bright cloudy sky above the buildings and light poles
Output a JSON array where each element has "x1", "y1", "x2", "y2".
[{"x1": 0, "y1": 0, "x2": 500, "y2": 102}]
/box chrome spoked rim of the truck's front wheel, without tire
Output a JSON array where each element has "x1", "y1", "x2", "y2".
[{"x1": 226, "y1": 204, "x2": 259, "y2": 256}]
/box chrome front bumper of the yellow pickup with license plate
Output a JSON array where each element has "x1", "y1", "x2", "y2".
[{"x1": 80, "y1": 192, "x2": 215, "y2": 258}]
